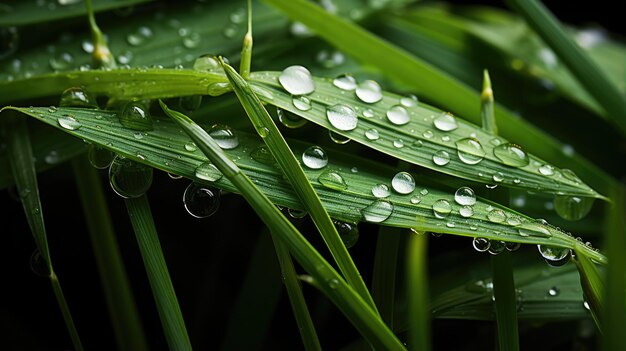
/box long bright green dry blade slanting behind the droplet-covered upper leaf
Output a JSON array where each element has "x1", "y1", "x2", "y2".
[{"x1": 266, "y1": 0, "x2": 615, "y2": 198}]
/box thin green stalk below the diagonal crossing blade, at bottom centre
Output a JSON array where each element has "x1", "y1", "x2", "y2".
[{"x1": 272, "y1": 233, "x2": 322, "y2": 351}]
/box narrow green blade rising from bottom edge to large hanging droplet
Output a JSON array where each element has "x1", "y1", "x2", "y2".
[{"x1": 124, "y1": 194, "x2": 191, "y2": 350}]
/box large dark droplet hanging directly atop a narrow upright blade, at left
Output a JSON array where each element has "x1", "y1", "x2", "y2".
[{"x1": 109, "y1": 156, "x2": 153, "y2": 199}]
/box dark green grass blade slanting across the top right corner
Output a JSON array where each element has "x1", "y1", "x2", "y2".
[{"x1": 506, "y1": 0, "x2": 626, "y2": 134}]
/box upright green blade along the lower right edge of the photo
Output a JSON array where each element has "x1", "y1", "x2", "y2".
[{"x1": 601, "y1": 186, "x2": 626, "y2": 351}]
